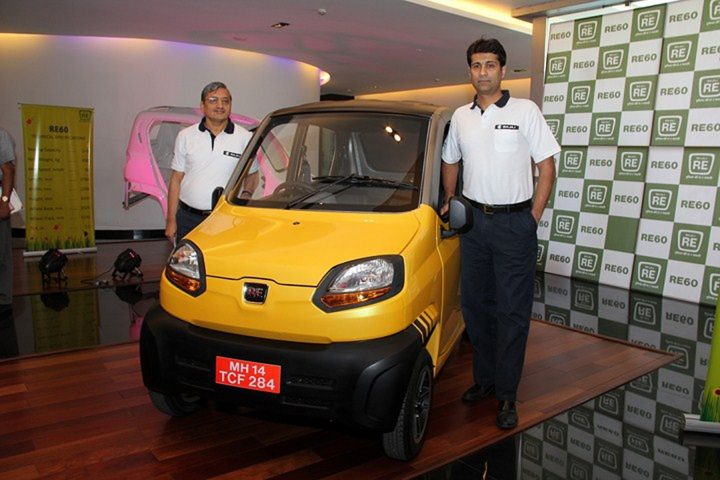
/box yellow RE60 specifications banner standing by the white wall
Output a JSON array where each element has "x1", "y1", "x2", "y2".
[{"x1": 20, "y1": 104, "x2": 96, "y2": 255}]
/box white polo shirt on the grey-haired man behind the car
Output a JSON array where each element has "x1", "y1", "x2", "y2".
[{"x1": 170, "y1": 119, "x2": 252, "y2": 210}]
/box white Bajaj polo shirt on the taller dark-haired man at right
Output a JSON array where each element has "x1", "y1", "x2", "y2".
[{"x1": 442, "y1": 91, "x2": 560, "y2": 205}]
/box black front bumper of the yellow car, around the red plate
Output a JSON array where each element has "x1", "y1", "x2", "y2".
[{"x1": 140, "y1": 306, "x2": 423, "y2": 431}]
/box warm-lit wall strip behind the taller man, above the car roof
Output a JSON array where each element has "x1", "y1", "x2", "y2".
[{"x1": 357, "y1": 78, "x2": 530, "y2": 109}]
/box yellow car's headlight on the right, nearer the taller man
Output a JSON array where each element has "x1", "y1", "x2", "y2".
[{"x1": 313, "y1": 255, "x2": 405, "y2": 312}]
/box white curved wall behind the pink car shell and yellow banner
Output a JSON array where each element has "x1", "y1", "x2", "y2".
[{"x1": 0, "y1": 34, "x2": 320, "y2": 230}]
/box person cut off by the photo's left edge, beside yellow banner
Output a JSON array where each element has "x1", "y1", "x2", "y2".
[{"x1": 0, "y1": 128, "x2": 15, "y2": 308}]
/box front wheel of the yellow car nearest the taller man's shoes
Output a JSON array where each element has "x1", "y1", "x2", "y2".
[{"x1": 383, "y1": 350, "x2": 433, "y2": 461}]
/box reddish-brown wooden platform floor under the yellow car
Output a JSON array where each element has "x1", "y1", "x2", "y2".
[{"x1": 0, "y1": 321, "x2": 677, "y2": 480}]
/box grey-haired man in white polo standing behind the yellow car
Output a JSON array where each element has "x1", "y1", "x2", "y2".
[{"x1": 165, "y1": 82, "x2": 258, "y2": 243}]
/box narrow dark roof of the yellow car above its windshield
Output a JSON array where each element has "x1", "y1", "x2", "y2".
[{"x1": 272, "y1": 100, "x2": 449, "y2": 116}]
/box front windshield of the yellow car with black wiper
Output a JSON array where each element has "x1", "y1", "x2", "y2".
[{"x1": 228, "y1": 112, "x2": 429, "y2": 212}]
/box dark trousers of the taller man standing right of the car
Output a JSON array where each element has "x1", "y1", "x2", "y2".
[{"x1": 460, "y1": 204, "x2": 538, "y2": 400}]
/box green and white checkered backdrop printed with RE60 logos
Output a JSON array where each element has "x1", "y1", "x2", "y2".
[{"x1": 538, "y1": 0, "x2": 720, "y2": 305}]
